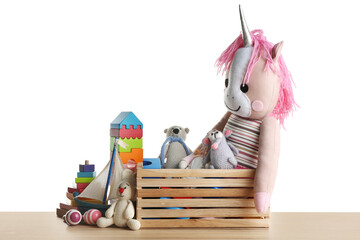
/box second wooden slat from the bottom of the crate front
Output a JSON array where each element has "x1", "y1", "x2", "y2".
[{"x1": 140, "y1": 208, "x2": 268, "y2": 218}]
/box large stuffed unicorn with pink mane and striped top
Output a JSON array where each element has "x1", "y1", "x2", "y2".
[{"x1": 183, "y1": 6, "x2": 296, "y2": 214}]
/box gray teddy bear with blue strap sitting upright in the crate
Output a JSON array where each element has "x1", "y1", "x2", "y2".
[{"x1": 164, "y1": 126, "x2": 191, "y2": 168}]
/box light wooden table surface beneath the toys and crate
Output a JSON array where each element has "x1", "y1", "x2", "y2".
[{"x1": 0, "y1": 212, "x2": 360, "y2": 240}]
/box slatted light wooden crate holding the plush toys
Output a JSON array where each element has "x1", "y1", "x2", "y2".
[{"x1": 136, "y1": 163, "x2": 269, "y2": 228}]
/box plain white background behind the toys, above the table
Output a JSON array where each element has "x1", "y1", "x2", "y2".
[{"x1": 0, "y1": 0, "x2": 360, "y2": 212}]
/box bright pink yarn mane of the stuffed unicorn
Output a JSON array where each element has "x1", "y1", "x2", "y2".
[{"x1": 215, "y1": 30, "x2": 297, "y2": 127}]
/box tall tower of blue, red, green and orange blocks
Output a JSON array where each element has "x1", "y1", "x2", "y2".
[{"x1": 110, "y1": 112, "x2": 143, "y2": 164}]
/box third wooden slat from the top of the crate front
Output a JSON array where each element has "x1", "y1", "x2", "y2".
[{"x1": 137, "y1": 188, "x2": 254, "y2": 197}]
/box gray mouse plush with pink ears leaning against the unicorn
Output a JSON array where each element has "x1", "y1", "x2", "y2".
[{"x1": 203, "y1": 130, "x2": 238, "y2": 169}]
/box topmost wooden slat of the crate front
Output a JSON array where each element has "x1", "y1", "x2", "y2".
[{"x1": 137, "y1": 169, "x2": 255, "y2": 178}]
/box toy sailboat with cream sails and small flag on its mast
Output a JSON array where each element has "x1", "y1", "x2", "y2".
[{"x1": 74, "y1": 138, "x2": 126, "y2": 215}]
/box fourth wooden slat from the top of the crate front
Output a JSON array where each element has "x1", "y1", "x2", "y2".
[{"x1": 137, "y1": 198, "x2": 255, "y2": 208}]
